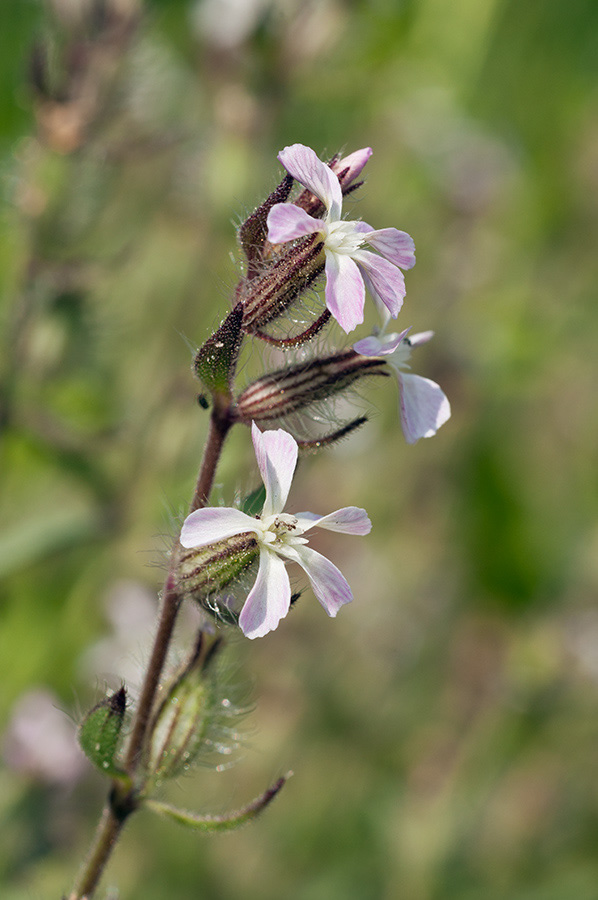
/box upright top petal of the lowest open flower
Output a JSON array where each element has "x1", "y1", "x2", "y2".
[{"x1": 251, "y1": 422, "x2": 298, "y2": 516}]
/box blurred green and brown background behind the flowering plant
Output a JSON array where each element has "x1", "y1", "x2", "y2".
[{"x1": 0, "y1": 0, "x2": 598, "y2": 900}]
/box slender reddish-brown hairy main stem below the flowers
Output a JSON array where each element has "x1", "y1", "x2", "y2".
[{"x1": 68, "y1": 398, "x2": 232, "y2": 900}]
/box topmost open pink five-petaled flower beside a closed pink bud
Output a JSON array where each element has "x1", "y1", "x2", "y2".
[{"x1": 268, "y1": 144, "x2": 415, "y2": 332}]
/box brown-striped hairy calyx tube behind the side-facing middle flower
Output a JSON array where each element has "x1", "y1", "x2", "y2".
[{"x1": 235, "y1": 350, "x2": 388, "y2": 425}]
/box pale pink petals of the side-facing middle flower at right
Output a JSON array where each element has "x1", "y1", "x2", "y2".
[{"x1": 353, "y1": 328, "x2": 451, "y2": 444}]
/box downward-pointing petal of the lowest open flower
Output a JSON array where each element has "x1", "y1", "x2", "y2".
[{"x1": 239, "y1": 548, "x2": 291, "y2": 640}]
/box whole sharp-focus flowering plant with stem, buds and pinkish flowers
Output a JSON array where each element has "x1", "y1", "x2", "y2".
[{"x1": 69, "y1": 144, "x2": 450, "y2": 900}]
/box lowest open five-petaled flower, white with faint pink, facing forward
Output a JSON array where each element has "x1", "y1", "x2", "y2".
[{"x1": 180, "y1": 423, "x2": 372, "y2": 638}]
